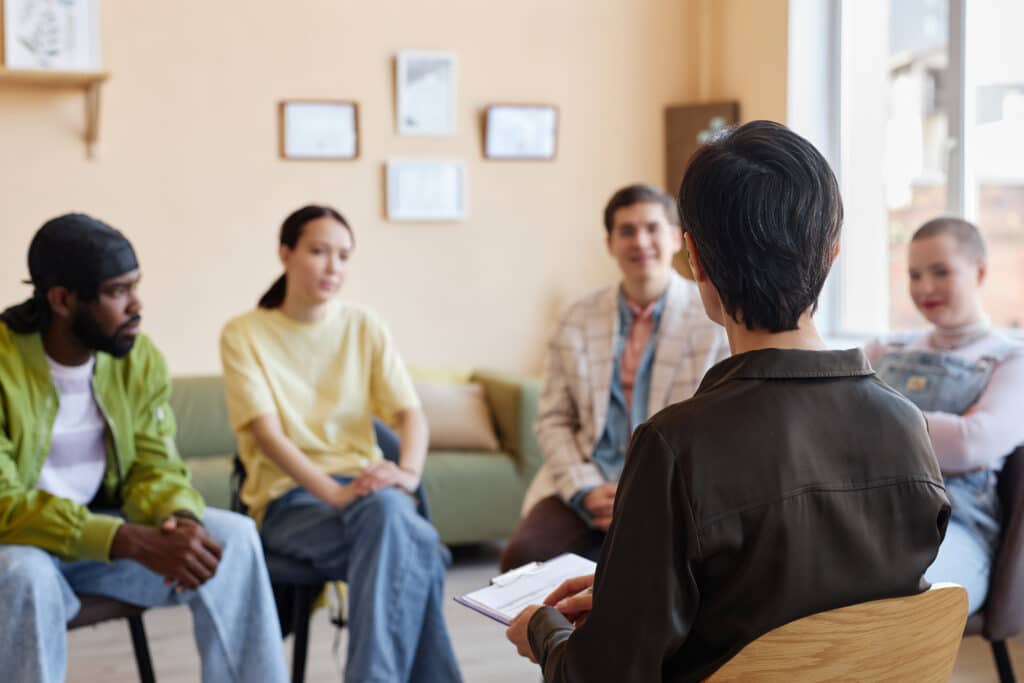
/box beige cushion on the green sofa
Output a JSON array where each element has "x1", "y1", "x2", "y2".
[{"x1": 416, "y1": 382, "x2": 501, "y2": 451}]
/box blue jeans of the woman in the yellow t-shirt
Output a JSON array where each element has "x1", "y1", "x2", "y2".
[{"x1": 262, "y1": 477, "x2": 462, "y2": 683}]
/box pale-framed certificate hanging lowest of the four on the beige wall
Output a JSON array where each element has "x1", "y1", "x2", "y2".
[{"x1": 386, "y1": 159, "x2": 466, "y2": 221}]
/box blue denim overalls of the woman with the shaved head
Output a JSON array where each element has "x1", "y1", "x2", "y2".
[{"x1": 874, "y1": 349, "x2": 999, "y2": 611}]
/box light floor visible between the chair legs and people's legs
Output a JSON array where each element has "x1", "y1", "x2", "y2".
[{"x1": 68, "y1": 547, "x2": 1024, "y2": 683}]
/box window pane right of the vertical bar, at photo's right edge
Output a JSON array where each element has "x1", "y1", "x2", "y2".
[{"x1": 965, "y1": 0, "x2": 1024, "y2": 328}]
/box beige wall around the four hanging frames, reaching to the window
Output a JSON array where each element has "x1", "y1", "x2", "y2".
[{"x1": 0, "y1": 0, "x2": 785, "y2": 373}]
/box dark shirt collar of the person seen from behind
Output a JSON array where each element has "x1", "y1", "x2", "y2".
[{"x1": 697, "y1": 348, "x2": 874, "y2": 393}]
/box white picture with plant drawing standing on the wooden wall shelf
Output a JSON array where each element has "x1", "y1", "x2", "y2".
[{"x1": 0, "y1": 0, "x2": 101, "y2": 72}]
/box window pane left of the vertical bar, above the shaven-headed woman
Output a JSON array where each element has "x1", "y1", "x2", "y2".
[{"x1": 884, "y1": 0, "x2": 950, "y2": 330}]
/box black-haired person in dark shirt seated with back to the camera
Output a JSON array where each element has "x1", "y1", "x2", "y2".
[{"x1": 508, "y1": 121, "x2": 949, "y2": 683}]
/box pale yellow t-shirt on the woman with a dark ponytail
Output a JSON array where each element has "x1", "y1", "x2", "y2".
[{"x1": 220, "y1": 301, "x2": 420, "y2": 523}]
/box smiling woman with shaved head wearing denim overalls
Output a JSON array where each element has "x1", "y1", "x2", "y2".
[{"x1": 866, "y1": 217, "x2": 1024, "y2": 611}]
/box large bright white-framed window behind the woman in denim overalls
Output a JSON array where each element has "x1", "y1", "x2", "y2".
[{"x1": 790, "y1": 0, "x2": 1024, "y2": 336}]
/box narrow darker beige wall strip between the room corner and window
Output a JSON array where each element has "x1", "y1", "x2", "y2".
[{"x1": 698, "y1": 0, "x2": 788, "y2": 123}]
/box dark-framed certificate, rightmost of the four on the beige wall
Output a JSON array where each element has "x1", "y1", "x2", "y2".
[{"x1": 483, "y1": 104, "x2": 558, "y2": 161}]
